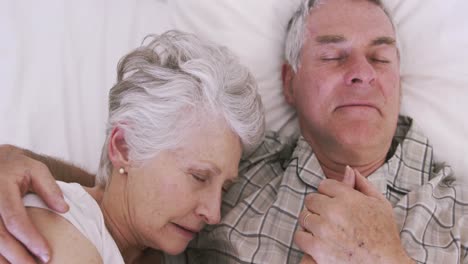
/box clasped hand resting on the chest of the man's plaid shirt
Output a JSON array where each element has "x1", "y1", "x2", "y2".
[{"x1": 295, "y1": 168, "x2": 413, "y2": 264}]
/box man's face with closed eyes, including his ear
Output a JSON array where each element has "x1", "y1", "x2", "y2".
[{"x1": 283, "y1": 0, "x2": 400, "y2": 161}]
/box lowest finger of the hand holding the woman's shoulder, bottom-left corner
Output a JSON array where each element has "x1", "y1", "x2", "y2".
[{"x1": 0, "y1": 218, "x2": 42, "y2": 264}]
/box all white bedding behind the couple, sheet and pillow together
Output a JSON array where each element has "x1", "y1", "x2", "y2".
[{"x1": 0, "y1": 0, "x2": 468, "y2": 177}]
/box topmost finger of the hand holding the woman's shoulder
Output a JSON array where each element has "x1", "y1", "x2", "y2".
[{"x1": 31, "y1": 163, "x2": 69, "y2": 213}]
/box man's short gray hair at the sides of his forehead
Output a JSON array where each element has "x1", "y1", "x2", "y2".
[{"x1": 285, "y1": 0, "x2": 398, "y2": 72}]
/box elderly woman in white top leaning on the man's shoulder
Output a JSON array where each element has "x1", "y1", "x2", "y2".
[{"x1": 24, "y1": 31, "x2": 264, "y2": 264}]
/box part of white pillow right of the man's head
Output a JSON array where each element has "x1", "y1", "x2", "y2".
[{"x1": 384, "y1": 0, "x2": 468, "y2": 179}]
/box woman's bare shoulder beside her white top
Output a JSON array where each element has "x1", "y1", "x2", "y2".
[{"x1": 27, "y1": 208, "x2": 102, "y2": 264}]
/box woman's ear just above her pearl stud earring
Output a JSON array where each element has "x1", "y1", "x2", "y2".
[{"x1": 107, "y1": 127, "x2": 130, "y2": 171}]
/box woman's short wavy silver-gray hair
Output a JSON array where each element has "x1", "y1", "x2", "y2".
[{"x1": 97, "y1": 31, "x2": 265, "y2": 186}]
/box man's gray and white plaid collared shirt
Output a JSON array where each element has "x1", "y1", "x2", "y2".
[{"x1": 168, "y1": 117, "x2": 468, "y2": 264}]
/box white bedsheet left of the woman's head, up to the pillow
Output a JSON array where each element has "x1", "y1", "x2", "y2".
[{"x1": 0, "y1": 0, "x2": 169, "y2": 171}]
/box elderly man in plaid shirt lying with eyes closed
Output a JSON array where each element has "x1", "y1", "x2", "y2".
[{"x1": 0, "y1": 0, "x2": 468, "y2": 263}]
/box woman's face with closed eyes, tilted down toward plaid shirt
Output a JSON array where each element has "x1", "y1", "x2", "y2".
[{"x1": 125, "y1": 122, "x2": 242, "y2": 254}]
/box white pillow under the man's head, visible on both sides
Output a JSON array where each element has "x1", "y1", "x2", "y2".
[{"x1": 169, "y1": 0, "x2": 468, "y2": 177}]
